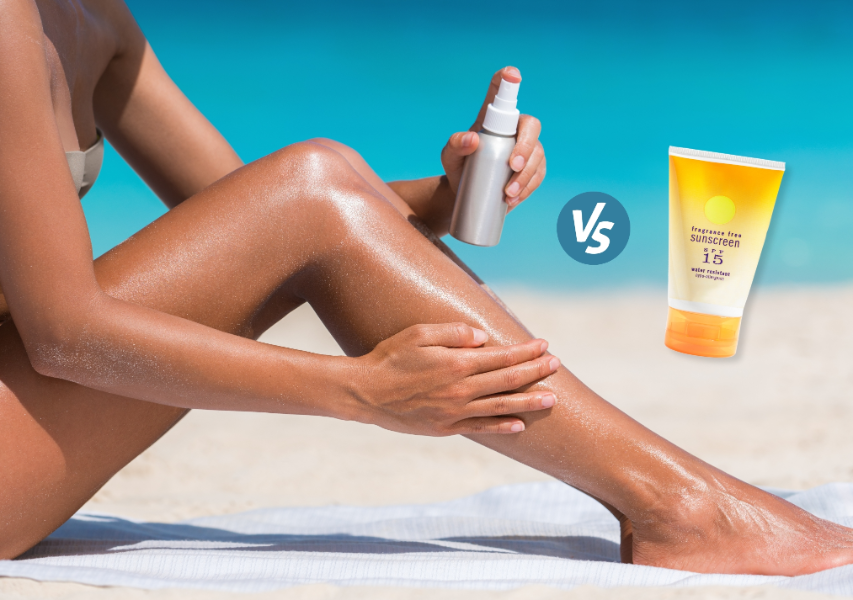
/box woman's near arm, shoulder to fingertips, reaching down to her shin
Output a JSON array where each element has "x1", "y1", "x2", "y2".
[{"x1": 0, "y1": 0, "x2": 550, "y2": 435}]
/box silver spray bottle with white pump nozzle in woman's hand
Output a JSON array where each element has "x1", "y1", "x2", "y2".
[{"x1": 450, "y1": 79, "x2": 519, "y2": 246}]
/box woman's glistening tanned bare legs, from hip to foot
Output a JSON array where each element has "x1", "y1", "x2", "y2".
[{"x1": 0, "y1": 138, "x2": 853, "y2": 574}]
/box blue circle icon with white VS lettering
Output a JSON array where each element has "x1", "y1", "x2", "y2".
[{"x1": 557, "y1": 192, "x2": 631, "y2": 265}]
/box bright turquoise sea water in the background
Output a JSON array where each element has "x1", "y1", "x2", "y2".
[{"x1": 84, "y1": 0, "x2": 853, "y2": 289}]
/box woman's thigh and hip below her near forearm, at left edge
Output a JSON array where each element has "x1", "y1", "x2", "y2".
[{"x1": 0, "y1": 322, "x2": 186, "y2": 559}]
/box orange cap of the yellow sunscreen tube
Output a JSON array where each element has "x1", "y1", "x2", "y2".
[{"x1": 664, "y1": 307, "x2": 741, "y2": 358}]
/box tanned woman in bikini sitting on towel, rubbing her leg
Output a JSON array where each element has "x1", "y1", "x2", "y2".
[{"x1": 0, "y1": 0, "x2": 853, "y2": 575}]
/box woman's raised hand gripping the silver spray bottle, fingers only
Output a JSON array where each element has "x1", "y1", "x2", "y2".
[{"x1": 441, "y1": 67, "x2": 545, "y2": 210}]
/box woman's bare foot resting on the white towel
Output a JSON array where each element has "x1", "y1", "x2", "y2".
[{"x1": 620, "y1": 473, "x2": 853, "y2": 576}]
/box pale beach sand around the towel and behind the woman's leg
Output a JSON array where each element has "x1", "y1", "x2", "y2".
[{"x1": 0, "y1": 287, "x2": 853, "y2": 600}]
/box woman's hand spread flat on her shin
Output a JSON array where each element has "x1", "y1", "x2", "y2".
[{"x1": 356, "y1": 323, "x2": 560, "y2": 436}]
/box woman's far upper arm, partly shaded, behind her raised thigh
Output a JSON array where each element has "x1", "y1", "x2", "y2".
[{"x1": 94, "y1": 0, "x2": 243, "y2": 208}]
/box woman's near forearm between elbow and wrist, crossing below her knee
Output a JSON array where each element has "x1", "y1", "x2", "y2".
[{"x1": 30, "y1": 295, "x2": 356, "y2": 419}]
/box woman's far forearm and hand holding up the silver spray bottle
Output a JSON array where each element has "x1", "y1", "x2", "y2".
[{"x1": 388, "y1": 67, "x2": 546, "y2": 237}]
